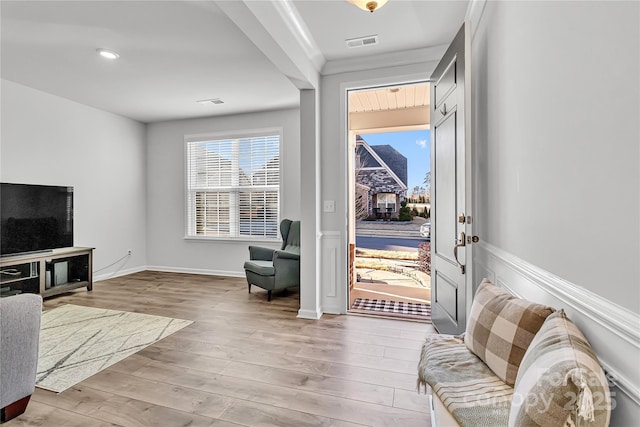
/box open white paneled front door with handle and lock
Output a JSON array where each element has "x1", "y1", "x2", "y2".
[{"x1": 431, "y1": 23, "x2": 473, "y2": 334}]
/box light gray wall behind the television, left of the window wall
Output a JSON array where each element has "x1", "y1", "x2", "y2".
[{"x1": 0, "y1": 80, "x2": 146, "y2": 280}]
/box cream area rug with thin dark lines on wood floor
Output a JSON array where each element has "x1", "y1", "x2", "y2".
[{"x1": 36, "y1": 304, "x2": 193, "y2": 393}]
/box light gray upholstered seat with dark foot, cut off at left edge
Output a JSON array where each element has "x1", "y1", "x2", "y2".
[{"x1": 0, "y1": 294, "x2": 42, "y2": 422}]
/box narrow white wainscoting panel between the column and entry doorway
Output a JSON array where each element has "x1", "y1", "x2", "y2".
[{"x1": 320, "y1": 231, "x2": 347, "y2": 314}]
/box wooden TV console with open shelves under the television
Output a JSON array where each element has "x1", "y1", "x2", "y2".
[{"x1": 0, "y1": 247, "x2": 93, "y2": 298}]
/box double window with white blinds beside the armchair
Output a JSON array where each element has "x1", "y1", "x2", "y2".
[{"x1": 186, "y1": 131, "x2": 280, "y2": 239}]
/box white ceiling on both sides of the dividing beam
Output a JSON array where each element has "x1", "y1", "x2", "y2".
[{"x1": 0, "y1": 0, "x2": 468, "y2": 123}]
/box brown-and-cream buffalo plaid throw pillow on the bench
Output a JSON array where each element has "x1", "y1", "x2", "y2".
[{"x1": 464, "y1": 279, "x2": 554, "y2": 386}]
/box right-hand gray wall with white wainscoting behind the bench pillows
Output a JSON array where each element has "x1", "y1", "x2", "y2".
[{"x1": 472, "y1": 1, "x2": 640, "y2": 426}]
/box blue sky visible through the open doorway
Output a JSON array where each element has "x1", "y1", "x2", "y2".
[{"x1": 361, "y1": 130, "x2": 431, "y2": 195}]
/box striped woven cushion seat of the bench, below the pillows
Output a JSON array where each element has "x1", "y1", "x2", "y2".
[{"x1": 418, "y1": 335, "x2": 513, "y2": 427}]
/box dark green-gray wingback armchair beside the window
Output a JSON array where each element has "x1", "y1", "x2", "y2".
[{"x1": 244, "y1": 219, "x2": 300, "y2": 301}]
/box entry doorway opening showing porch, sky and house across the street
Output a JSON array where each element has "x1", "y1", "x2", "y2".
[{"x1": 347, "y1": 82, "x2": 431, "y2": 321}]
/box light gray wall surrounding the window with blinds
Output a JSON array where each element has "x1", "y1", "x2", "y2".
[{"x1": 147, "y1": 109, "x2": 300, "y2": 276}]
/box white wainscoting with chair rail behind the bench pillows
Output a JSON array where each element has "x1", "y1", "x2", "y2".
[{"x1": 474, "y1": 242, "x2": 640, "y2": 426}]
